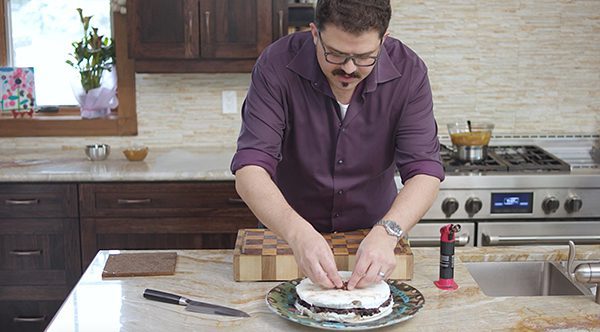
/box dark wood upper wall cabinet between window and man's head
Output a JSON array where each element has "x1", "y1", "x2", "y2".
[{"x1": 127, "y1": 0, "x2": 287, "y2": 73}]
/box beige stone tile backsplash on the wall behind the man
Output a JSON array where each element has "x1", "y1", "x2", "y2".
[{"x1": 0, "y1": 0, "x2": 600, "y2": 148}]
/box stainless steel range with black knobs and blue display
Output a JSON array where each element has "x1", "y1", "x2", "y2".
[{"x1": 397, "y1": 139, "x2": 600, "y2": 246}]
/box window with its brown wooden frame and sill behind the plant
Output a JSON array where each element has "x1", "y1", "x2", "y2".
[{"x1": 0, "y1": 0, "x2": 137, "y2": 137}]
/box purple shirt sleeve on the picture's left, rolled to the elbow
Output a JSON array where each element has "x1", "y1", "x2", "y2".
[{"x1": 231, "y1": 57, "x2": 286, "y2": 178}]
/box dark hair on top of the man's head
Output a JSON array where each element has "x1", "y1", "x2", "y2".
[{"x1": 315, "y1": 0, "x2": 392, "y2": 38}]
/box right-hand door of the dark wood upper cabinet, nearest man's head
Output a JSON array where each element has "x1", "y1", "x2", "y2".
[{"x1": 199, "y1": 0, "x2": 276, "y2": 59}]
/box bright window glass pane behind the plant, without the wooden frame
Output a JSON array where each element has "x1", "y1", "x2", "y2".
[{"x1": 8, "y1": 0, "x2": 111, "y2": 106}]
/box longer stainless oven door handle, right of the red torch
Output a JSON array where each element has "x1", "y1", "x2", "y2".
[{"x1": 482, "y1": 233, "x2": 600, "y2": 246}]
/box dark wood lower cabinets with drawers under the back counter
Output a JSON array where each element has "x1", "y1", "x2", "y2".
[{"x1": 0, "y1": 181, "x2": 258, "y2": 332}]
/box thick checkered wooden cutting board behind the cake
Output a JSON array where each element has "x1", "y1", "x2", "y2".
[{"x1": 233, "y1": 229, "x2": 413, "y2": 281}]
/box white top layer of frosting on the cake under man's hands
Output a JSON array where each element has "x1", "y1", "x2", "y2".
[{"x1": 296, "y1": 271, "x2": 390, "y2": 309}]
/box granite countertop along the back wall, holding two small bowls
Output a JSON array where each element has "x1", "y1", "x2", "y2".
[{"x1": 0, "y1": 148, "x2": 235, "y2": 182}]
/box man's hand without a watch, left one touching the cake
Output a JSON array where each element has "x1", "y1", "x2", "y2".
[{"x1": 289, "y1": 230, "x2": 343, "y2": 288}]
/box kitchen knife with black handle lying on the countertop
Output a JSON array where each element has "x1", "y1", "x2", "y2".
[{"x1": 144, "y1": 288, "x2": 250, "y2": 317}]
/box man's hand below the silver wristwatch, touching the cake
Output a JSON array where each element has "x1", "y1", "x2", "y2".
[{"x1": 348, "y1": 226, "x2": 397, "y2": 290}]
